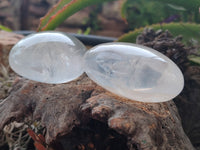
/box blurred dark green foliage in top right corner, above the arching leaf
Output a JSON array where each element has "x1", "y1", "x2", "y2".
[{"x1": 121, "y1": 0, "x2": 200, "y2": 30}]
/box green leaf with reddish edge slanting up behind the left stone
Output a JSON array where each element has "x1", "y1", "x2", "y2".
[{"x1": 38, "y1": 0, "x2": 113, "y2": 31}]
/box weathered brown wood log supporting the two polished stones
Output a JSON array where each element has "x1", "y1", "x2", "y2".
[{"x1": 0, "y1": 75, "x2": 193, "y2": 150}]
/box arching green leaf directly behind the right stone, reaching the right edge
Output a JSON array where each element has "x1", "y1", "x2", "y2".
[{"x1": 118, "y1": 23, "x2": 200, "y2": 43}]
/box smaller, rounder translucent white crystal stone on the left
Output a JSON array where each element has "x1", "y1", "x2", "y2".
[{"x1": 9, "y1": 32, "x2": 86, "y2": 83}]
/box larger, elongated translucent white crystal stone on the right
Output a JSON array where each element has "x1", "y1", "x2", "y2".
[{"x1": 84, "y1": 43, "x2": 184, "y2": 102}]
